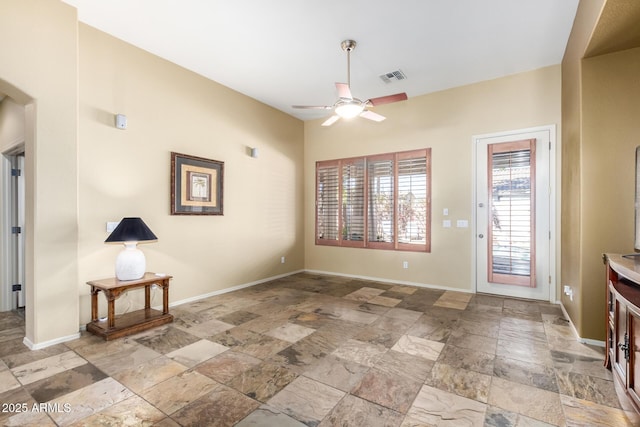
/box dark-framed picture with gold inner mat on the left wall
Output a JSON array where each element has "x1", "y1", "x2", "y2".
[{"x1": 171, "y1": 152, "x2": 224, "y2": 215}]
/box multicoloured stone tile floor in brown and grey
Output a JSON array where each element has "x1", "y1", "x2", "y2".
[{"x1": 0, "y1": 273, "x2": 640, "y2": 427}]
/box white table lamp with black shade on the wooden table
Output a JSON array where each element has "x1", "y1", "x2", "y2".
[{"x1": 104, "y1": 218, "x2": 158, "y2": 280}]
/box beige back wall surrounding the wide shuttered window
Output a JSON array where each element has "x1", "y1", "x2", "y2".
[{"x1": 305, "y1": 66, "x2": 561, "y2": 290}]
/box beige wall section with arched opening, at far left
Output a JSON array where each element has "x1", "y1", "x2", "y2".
[{"x1": 0, "y1": 0, "x2": 78, "y2": 345}]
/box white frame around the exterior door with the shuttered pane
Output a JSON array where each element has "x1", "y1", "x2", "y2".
[{"x1": 471, "y1": 125, "x2": 557, "y2": 303}]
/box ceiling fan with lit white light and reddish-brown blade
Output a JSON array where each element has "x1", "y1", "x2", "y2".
[{"x1": 292, "y1": 40, "x2": 407, "y2": 126}]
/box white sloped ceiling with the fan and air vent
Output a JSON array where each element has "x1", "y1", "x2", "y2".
[{"x1": 63, "y1": 0, "x2": 579, "y2": 120}]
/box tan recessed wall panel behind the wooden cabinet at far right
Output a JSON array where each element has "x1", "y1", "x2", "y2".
[{"x1": 581, "y1": 48, "x2": 640, "y2": 339}]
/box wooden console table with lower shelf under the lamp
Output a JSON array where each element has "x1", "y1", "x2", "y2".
[{"x1": 87, "y1": 273, "x2": 173, "y2": 340}]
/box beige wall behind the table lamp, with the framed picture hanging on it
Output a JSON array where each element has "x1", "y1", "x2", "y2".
[{"x1": 77, "y1": 24, "x2": 304, "y2": 323}]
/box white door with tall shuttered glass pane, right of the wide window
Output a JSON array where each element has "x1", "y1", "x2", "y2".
[{"x1": 474, "y1": 128, "x2": 554, "y2": 301}]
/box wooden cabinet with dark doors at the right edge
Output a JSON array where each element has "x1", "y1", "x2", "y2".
[{"x1": 605, "y1": 254, "x2": 640, "y2": 413}]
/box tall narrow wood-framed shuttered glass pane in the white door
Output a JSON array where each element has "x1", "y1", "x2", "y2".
[{"x1": 488, "y1": 139, "x2": 536, "y2": 286}]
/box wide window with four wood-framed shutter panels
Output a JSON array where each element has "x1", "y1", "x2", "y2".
[{"x1": 316, "y1": 149, "x2": 431, "y2": 252}]
